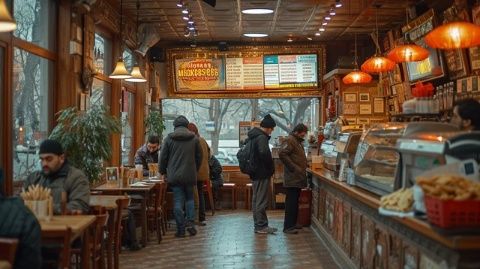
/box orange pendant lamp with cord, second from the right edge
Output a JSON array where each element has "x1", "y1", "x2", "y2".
[{"x1": 387, "y1": 3, "x2": 430, "y2": 63}]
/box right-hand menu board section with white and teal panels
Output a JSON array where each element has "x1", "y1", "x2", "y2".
[{"x1": 263, "y1": 54, "x2": 318, "y2": 89}]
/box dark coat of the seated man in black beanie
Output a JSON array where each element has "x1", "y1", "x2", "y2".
[{"x1": 23, "y1": 161, "x2": 90, "y2": 214}]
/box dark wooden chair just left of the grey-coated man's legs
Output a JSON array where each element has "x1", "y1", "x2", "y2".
[{"x1": 147, "y1": 183, "x2": 167, "y2": 244}]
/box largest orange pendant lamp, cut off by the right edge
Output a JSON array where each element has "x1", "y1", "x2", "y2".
[{"x1": 425, "y1": 22, "x2": 480, "y2": 50}]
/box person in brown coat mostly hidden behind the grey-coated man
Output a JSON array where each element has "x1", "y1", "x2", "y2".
[{"x1": 188, "y1": 123, "x2": 210, "y2": 226}]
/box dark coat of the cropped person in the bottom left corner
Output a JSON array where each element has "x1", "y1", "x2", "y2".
[{"x1": 0, "y1": 195, "x2": 42, "y2": 269}]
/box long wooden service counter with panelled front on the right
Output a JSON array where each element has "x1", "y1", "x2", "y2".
[{"x1": 308, "y1": 169, "x2": 480, "y2": 269}]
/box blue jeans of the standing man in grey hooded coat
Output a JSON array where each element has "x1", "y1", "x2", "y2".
[{"x1": 172, "y1": 186, "x2": 195, "y2": 234}]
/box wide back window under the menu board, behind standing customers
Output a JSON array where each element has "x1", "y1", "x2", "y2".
[{"x1": 162, "y1": 98, "x2": 319, "y2": 165}]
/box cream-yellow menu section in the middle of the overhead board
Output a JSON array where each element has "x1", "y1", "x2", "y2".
[{"x1": 225, "y1": 57, "x2": 263, "y2": 90}]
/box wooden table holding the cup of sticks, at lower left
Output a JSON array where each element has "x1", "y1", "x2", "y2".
[{"x1": 40, "y1": 215, "x2": 96, "y2": 268}]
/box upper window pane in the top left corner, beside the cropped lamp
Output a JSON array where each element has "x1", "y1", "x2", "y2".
[{"x1": 14, "y1": 0, "x2": 57, "y2": 50}]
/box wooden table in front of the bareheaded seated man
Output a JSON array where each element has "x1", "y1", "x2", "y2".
[{"x1": 92, "y1": 183, "x2": 155, "y2": 246}]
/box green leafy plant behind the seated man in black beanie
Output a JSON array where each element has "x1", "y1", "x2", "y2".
[{"x1": 50, "y1": 105, "x2": 121, "y2": 182}]
